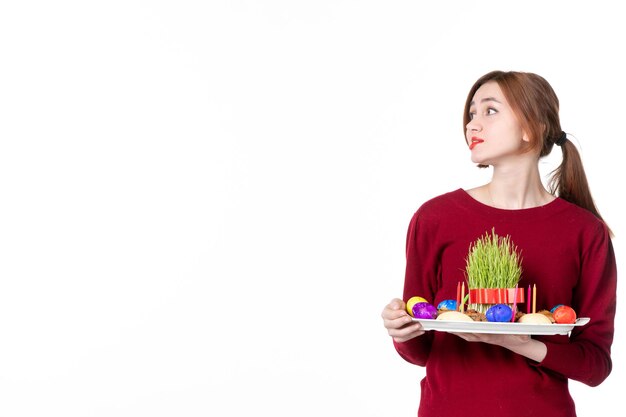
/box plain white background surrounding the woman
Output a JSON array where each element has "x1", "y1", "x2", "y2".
[{"x1": 0, "y1": 0, "x2": 626, "y2": 417}]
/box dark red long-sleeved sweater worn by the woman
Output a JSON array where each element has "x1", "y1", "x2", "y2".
[{"x1": 394, "y1": 189, "x2": 617, "y2": 417}]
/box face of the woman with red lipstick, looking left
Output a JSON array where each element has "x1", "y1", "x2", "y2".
[{"x1": 465, "y1": 81, "x2": 528, "y2": 166}]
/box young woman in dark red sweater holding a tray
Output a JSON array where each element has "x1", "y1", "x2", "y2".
[{"x1": 382, "y1": 71, "x2": 616, "y2": 417}]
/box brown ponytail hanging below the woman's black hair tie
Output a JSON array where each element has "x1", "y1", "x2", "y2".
[{"x1": 548, "y1": 134, "x2": 613, "y2": 237}]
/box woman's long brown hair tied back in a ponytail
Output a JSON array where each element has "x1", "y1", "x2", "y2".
[{"x1": 463, "y1": 71, "x2": 612, "y2": 235}]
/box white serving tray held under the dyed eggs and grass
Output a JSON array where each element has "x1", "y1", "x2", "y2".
[{"x1": 413, "y1": 317, "x2": 590, "y2": 335}]
